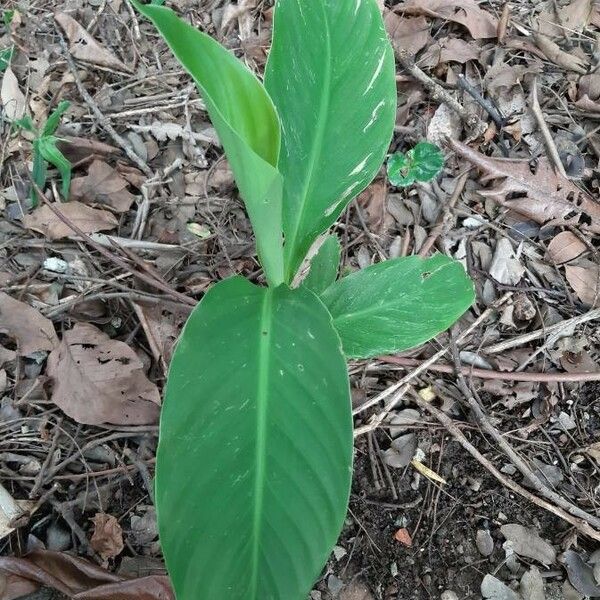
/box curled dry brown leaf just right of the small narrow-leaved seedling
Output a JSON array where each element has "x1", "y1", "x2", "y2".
[{"x1": 71, "y1": 160, "x2": 135, "y2": 213}]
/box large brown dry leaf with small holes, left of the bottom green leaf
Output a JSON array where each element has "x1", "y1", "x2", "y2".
[{"x1": 47, "y1": 323, "x2": 160, "y2": 425}]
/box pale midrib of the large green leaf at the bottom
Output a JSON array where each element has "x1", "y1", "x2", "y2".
[{"x1": 250, "y1": 288, "x2": 273, "y2": 600}]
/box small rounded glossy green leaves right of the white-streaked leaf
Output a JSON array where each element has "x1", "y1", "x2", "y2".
[{"x1": 388, "y1": 142, "x2": 444, "y2": 187}]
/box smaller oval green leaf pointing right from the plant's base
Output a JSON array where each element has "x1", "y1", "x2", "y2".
[{"x1": 322, "y1": 254, "x2": 475, "y2": 358}]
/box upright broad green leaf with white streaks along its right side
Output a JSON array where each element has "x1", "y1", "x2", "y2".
[{"x1": 265, "y1": 0, "x2": 396, "y2": 282}]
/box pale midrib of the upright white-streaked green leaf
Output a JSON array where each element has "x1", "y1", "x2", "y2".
[{"x1": 285, "y1": 1, "x2": 331, "y2": 283}]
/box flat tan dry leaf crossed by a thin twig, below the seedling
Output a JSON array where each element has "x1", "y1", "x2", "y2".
[{"x1": 23, "y1": 201, "x2": 119, "y2": 240}]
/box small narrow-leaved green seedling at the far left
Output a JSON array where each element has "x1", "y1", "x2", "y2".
[{"x1": 14, "y1": 100, "x2": 71, "y2": 206}]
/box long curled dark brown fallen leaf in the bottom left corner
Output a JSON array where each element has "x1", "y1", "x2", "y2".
[{"x1": 0, "y1": 550, "x2": 175, "y2": 600}]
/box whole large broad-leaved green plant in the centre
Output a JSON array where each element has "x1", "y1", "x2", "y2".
[{"x1": 134, "y1": 0, "x2": 473, "y2": 600}]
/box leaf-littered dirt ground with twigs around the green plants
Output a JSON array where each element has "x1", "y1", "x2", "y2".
[{"x1": 0, "y1": 0, "x2": 600, "y2": 600}]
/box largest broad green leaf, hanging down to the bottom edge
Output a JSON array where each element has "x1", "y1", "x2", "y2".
[{"x1": 156, "y1": 277, "x2": 352, "y2": 600}]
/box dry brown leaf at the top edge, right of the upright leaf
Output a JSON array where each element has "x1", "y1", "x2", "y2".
[{"x1": 395, "y1": 0, "x2": 498, "y2": 40}]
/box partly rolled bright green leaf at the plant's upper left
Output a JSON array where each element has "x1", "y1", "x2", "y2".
[{"x1": 132, "y1": 0, "x2": 283, "y2": 285}]
